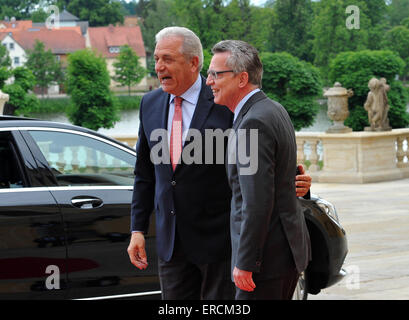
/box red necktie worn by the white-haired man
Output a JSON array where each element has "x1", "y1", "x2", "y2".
[{"x1": 170, "y1": 97, "x2": 183, "y2": 171}]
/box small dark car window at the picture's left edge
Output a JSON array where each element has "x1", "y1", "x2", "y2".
[{"x1": 0, "y1": 135, "x2": 24, "y2": 189}]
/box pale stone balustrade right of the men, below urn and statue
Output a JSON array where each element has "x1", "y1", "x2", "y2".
[{"x1": 296, "y1": 129, "x2": 409, "y2": 183}]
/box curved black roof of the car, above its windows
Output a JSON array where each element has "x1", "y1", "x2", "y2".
[{"x1": 0, "y1": 115, "x2": 135, "y2": 151}]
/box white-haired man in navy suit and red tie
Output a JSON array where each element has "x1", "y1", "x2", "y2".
[{"x1": 128, "y1": 27, "x2": 311, "y2": 300}]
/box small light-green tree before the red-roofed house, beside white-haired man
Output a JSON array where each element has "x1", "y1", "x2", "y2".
[{"x1": 112, "y1": 45, "x2": 146, "y2": 95}]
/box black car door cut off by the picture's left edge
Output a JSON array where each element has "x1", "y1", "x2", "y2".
[{"x1": 0, "y1": 128, "x2": 66, "y2": 300}]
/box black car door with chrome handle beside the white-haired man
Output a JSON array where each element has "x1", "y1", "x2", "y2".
[{"x1": 22, "y1": 129, "x2": 159, "y2": 298}]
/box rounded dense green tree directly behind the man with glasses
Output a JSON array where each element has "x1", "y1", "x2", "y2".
[{"x1": 261, "y1": 52, "x2": 322, "y2": 130}]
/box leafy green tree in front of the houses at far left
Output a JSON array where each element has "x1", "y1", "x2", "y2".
[{"x1": 26, "y1": 40, "x2": 64, "y2": 95}]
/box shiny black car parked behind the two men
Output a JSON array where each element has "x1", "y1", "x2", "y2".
[{"x1": 0, "y1": 116, "x2": 347, "y2": 299}]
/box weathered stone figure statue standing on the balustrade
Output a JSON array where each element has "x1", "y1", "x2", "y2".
[{"x1": 364, "y1": 78, "x2": 392, "y2": 131}]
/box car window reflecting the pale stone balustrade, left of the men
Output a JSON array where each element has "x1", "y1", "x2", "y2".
[{"x1": 29, "y1": 130, "x2": 135, "y2": 186}]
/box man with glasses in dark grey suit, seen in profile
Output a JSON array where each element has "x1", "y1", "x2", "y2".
[{"x1": 207, "y1": 40, "x2": 310, "y2": 299}]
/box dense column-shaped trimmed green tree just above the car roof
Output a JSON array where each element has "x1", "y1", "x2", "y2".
[{"x1": 66, "y1": 49, "x2": 119, "y2": 130}]
